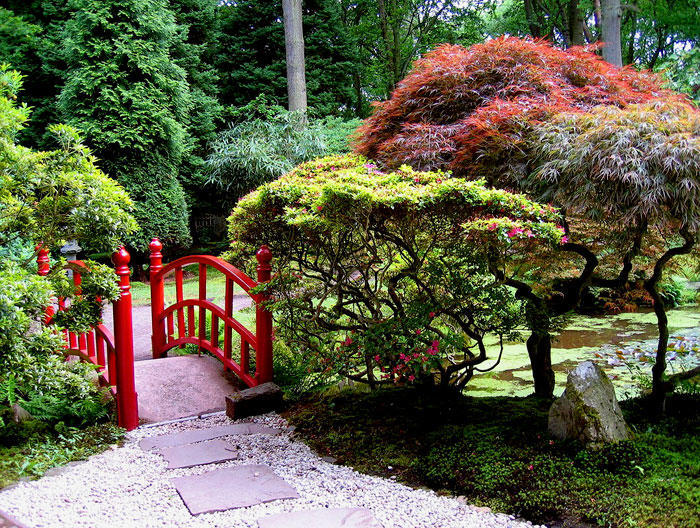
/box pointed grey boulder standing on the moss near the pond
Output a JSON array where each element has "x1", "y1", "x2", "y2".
[{"x1": 549, "y1": 361, "x2": 631, "y2": 446}]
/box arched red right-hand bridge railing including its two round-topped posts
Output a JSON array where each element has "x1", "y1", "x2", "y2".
[{"x1": 149, "y1": 238, "x2": 272, "y2": 387}]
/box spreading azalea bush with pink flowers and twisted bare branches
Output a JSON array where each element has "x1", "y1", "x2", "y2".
[{"x1": 230, "y1": 155, "x2": 564, "y2": 388}]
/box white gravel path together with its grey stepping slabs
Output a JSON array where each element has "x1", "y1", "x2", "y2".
[{"x1": 0, "y1": 413, "x2": 532, "y2": 528}]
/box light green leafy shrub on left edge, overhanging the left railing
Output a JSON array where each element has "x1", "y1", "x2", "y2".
[{"x1": 0, "y1": 67, "x2": 136, "y2": 432}]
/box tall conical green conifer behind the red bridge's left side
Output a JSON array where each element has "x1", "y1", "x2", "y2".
[{"x1": 59, "y1": 0, "x2": 193, "y2": 250}]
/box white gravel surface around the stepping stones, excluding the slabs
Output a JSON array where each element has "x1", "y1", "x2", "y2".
[{"x1": 0, "y1": 413, "x2": 548, "y2": 528}]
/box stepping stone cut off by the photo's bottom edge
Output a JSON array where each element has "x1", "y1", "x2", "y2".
[{"x1": 258, "y1": 508, "x2": 382, "y2": 528}]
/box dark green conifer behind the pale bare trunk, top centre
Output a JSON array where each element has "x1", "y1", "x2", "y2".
[{"x1": 217, "y1": 0, "x2": 355, "y2": 115}]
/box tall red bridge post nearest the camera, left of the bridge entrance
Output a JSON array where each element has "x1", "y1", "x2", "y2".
[{"x1": 110, "y1": 246, "x2": 139, "y2": 431}]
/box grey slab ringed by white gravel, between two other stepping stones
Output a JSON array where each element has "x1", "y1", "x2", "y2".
[{"x1": 172, "y1": 465, "x2": 299, "y2": 515}]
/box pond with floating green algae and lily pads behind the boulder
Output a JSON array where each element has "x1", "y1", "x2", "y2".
[{"x1": 465, "y1": 305, "x2": 700, "y2": 398}]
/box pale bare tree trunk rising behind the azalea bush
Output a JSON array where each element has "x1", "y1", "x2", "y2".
[{"x1": 282, "y1": 0, "x2": 306, "y2": 112}]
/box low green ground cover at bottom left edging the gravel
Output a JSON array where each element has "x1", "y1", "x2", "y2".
[{"x1": 0, "y1": 424, "x2": 124, "y2": 489}]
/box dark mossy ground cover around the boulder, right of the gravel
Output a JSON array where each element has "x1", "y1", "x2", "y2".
[{"x1": 286, "y1": 388, "x2": 700, "y2": 528}]
